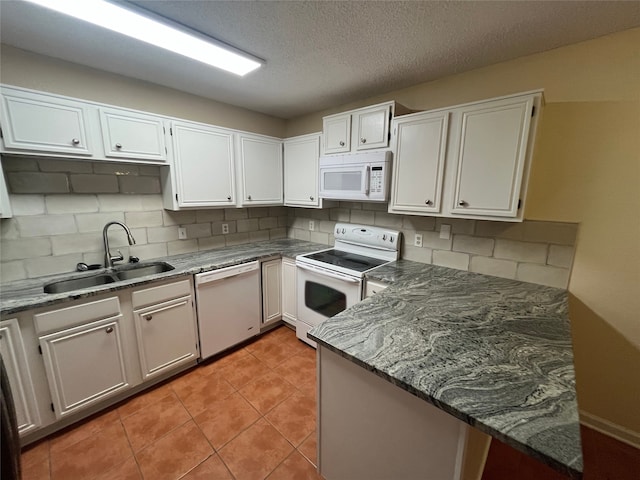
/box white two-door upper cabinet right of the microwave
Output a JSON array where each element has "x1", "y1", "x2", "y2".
[{"x1": 389, "y1": 92, "x2": 543, "y2": 222}]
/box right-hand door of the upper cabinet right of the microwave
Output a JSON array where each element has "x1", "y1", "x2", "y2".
[{"x1": 451, "y1": 97, "x2": 533, "y2": 217}]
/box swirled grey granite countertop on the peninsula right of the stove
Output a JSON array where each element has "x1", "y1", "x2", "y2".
[{"x1": 309, "y1": 260, "x2": 582, "y2": 478}]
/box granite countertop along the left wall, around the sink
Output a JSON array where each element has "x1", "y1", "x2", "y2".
[{"x1": 0, "y1": 238, "x2": 329, "y2": 315}]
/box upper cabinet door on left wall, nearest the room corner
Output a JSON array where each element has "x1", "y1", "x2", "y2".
[{"x1": 239, "y1": 135, "x2": 283, "y2": 206}]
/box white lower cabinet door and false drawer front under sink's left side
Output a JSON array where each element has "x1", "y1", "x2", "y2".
[{"x1": 34, "y1": 297, "x2": 130, "y2": 418}]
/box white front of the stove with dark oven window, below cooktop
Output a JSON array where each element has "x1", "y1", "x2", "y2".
[{"x1": 296, "y1": 263, "x2": 362, "y2": 347}]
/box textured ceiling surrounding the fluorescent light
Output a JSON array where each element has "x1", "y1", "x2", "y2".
[{"x1": 0, "y1": 0, "x2": 640, "y2": 118}]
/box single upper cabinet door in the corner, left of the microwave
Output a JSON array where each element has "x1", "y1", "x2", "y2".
[{"x1": 284, "y1": 134, "x2": 320, "y2": 207}]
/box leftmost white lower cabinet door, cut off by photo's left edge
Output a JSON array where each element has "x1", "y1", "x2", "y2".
[{"x1": 0, "y1": 318, "x2": 40, "y2": 435}]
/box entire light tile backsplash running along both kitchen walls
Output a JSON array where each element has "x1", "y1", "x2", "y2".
[{"x1": 0, "y1": 157, "x2": 578, "y2": 288}]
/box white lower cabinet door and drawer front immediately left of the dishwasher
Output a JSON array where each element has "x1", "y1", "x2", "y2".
[{"x1": 132, "y1": 280, "x2": 198, "y2": 380}]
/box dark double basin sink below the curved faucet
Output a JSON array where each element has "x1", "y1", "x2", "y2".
[{"x1": 44, "y1": 262, "x2": 175, "y2": 293}]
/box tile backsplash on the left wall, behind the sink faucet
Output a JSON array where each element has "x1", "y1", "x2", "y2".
[{"x1": 0, "y1": 157, "x2": 288, "y2": 283}]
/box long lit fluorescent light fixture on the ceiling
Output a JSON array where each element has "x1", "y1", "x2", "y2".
[{"x1": 26, "y1": 0, "x2": 264, "y2": 76}]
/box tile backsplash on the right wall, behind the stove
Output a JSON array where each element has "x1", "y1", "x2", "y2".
[{"x1": 288, "y1": 202, "x2": 578, "y2": 288}]
